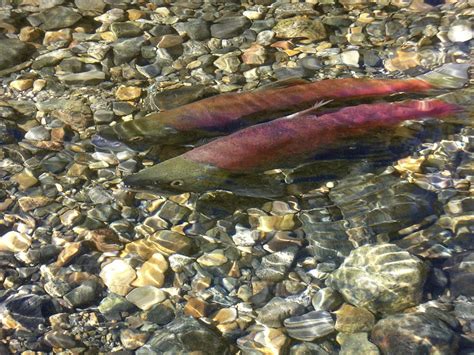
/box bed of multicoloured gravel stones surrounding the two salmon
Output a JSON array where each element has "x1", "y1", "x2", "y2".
[{"x1": 0, "y1": 0, "x2": 474, "y2": 355}]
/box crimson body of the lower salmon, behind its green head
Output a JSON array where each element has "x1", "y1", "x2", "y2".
[{"x1": 182, "y1": 99, "x2": 459, "y2": 172}]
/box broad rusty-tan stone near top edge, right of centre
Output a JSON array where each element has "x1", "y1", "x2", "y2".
[{"x1": 273, "y1": 16, "x2": 326, "y2": 41}]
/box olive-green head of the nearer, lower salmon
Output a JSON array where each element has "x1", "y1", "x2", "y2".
[{"x1": 124, "y1": 155, "x2": 227, "y2": 195}]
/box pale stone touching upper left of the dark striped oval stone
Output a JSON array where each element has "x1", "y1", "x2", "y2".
[{"x1": 257, "y1": 297, "x2": 305, "y2": 328}]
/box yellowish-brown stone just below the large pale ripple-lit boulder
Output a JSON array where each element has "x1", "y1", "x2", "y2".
[{"x1": 335, "y1": 304, "x2": 375, "y2": 333}]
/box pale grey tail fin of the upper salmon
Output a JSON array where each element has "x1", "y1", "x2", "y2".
[{"x1": 418, "y1": 63, "x2": 470, "y2": 89}]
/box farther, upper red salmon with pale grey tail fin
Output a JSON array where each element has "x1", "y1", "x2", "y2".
[{"x1": 92, "y1": 64, "x2": 468, "y2": 148}]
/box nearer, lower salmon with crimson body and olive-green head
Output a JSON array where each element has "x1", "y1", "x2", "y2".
[{"x1": 124, "y1": 90, "x2": 472, "y2": 195}]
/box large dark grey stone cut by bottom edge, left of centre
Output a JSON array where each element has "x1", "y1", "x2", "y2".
[{"x1": 147, "y1": 316, "x2": 231, "y2": 355}]
